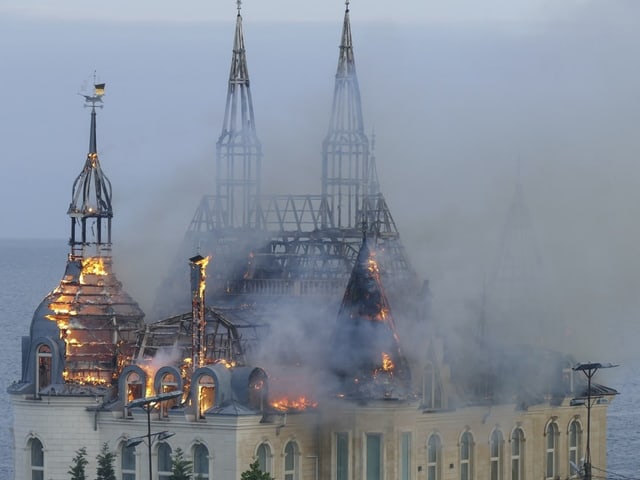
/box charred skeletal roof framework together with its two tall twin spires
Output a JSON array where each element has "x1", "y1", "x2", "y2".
[{"x1": 156, "y1": 3, "x2": 420, "y2": 342}]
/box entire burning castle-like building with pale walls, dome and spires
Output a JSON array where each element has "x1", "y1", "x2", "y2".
[{"x1": 9, "y1": 2, "x2": 615, "y2": 480}]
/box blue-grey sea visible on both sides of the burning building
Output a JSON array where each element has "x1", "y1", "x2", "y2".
[{"x1": 0, "y1": 239, "x2": 640, "y2": 480}]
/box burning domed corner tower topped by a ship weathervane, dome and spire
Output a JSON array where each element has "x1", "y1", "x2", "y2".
[{"x1": 11, "y1": 84, "x2": 144, "y2": 398}]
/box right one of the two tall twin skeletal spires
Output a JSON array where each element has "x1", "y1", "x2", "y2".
[{"x1": 322, "y1": 1, "x2": 369, "y2": 227}]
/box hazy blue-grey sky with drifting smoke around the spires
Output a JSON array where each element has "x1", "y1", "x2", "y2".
[{"x1": 0, "y1": 0, "x2": 640, "y2": 361}]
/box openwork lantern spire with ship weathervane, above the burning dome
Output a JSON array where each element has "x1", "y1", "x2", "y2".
[{"x1": 67, "y1": 84, "x2": 113, "y2": 258}]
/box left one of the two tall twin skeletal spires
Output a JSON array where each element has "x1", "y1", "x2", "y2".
[{"x1": 216, "y1": 0, "x2": 262, "y2": 227}]
